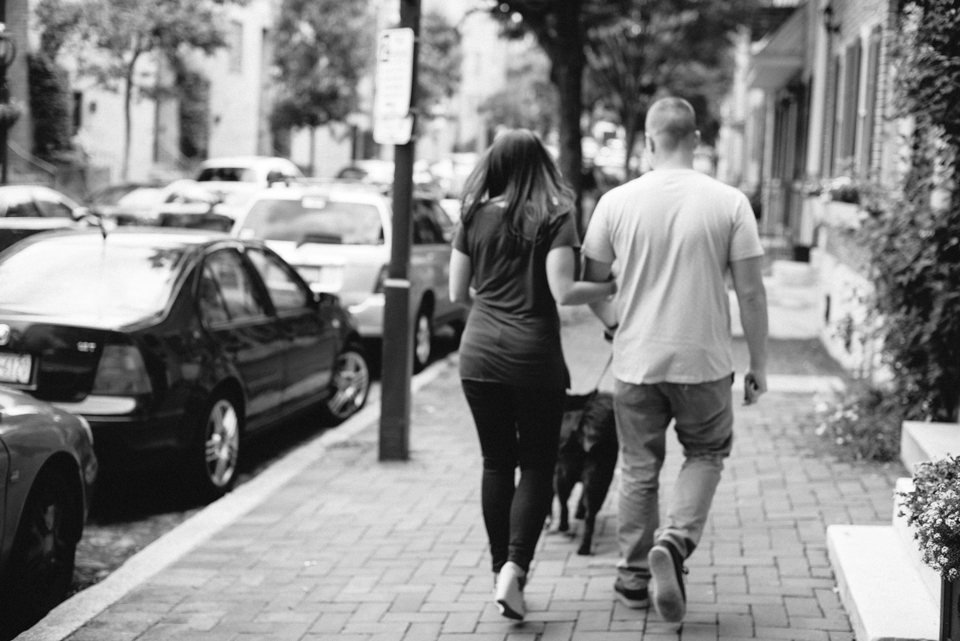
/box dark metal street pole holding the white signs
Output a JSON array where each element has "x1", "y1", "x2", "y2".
[{"x1": 380, "y1": 0, "x2": 420, "y2": 461}]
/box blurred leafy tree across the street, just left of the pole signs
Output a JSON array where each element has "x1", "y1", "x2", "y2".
[{"x1": 270, "y1": 0, "x2": 373, "y2": 173}]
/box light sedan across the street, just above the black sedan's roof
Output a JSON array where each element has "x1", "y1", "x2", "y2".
[{"x1": 87, "y1": 179, "x2": 227, "y2": 231}]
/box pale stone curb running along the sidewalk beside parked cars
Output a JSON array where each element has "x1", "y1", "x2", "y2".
[{"x1": 14, "y1": 358, "x2": 453, "y2": 641}]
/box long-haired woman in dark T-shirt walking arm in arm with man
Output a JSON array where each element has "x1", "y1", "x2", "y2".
[{"x1": 450, "y1": 130, "x2": 615, "y2": 619}]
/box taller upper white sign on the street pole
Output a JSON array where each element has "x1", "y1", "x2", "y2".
[{"x1": 373, "y1": 28, "x2": 414, "y2": 120}]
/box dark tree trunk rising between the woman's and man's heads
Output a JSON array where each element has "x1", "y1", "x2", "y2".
[{"x1": 488, "y1": 0, "x2": 631, "y2": 220}]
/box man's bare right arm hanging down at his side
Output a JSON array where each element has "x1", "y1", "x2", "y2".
[{"x1": 730, "y1": 256, "x2": 769, "y2": 404}]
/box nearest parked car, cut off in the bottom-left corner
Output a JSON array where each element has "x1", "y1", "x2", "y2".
[{"x1": 0, "y1": 384, "x2": 97, "y2": 629}]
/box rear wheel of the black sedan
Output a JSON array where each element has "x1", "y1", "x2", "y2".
[{"x1": 190, "y1": 391, "x2": 244, "y2": 501}]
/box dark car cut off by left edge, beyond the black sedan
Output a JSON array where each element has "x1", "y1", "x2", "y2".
[{"x1": 0, "y1": 185, "x2": 89, "y2": 250}]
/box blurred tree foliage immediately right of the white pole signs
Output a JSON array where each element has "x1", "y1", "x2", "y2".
[{"x1": 417, "y1": 11, "x2": 463, "y2": 118}]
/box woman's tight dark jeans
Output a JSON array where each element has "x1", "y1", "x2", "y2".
[{"x1": 462, "y1": 380, "x2": 566, "y2": 572}]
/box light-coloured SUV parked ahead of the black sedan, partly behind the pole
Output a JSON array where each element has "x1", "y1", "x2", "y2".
[{"x1": 234, "y1": 183, "x2": 466, "y2": 371}]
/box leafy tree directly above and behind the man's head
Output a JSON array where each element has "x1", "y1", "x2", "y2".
[{"x1": 587, "y1": 0, "x2": 748, "y2": 175}]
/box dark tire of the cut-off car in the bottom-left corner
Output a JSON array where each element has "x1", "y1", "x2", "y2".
[{"x1": 3, "y1": 470, "x2": 83, "y2": 625}]
